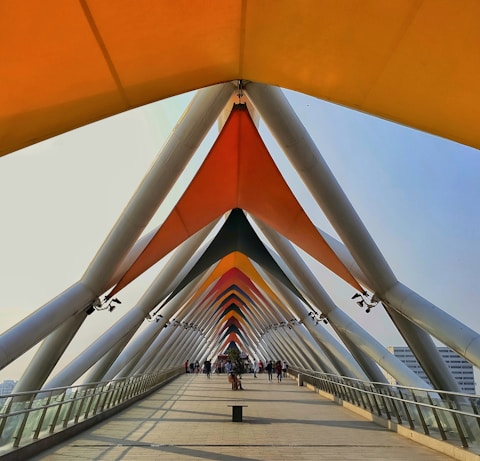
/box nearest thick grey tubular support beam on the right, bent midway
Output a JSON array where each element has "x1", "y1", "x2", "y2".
[{"x1": 246, "y1": 82, "x2": 480, "y2": 367}]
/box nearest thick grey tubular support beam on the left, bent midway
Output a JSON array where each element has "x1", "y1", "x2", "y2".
[{"x1": 0, "y1": 83, "x2": 233, "y2": 369}]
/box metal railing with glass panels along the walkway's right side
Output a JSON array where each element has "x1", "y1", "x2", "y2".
[{"x1": 289, "y1": 367, "x2": 480, "y2": 452}]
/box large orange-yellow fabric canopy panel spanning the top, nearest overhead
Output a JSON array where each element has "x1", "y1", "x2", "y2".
[{"x1": 0, "y1": 0, "x2": 480, "y2": 155}]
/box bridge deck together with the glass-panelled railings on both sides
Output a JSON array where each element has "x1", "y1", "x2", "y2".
[{"x1": 0, "y1": 369, "x2": 480, "y2": 461}]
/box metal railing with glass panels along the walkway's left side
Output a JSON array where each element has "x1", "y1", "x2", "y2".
[{"x1": 0, "y1": 367, "x2": 184, "y2": 457}]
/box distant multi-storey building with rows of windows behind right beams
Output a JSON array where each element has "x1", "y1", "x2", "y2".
[{"x1": 388, "y1": 346, "x2": 476, "y2": 394}]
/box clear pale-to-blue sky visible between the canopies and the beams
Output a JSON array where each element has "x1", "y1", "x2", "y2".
[{"x1": 0, "y1": 87, "x2": 480, "y2": 388}]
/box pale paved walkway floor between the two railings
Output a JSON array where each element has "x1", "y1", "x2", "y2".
[{"x1": 35, "y1": 374, "x2": 451, "y2": 461}]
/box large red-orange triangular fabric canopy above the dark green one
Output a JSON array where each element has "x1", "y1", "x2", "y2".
[{"x1": 109, "y1": 105, "x2": 363, "y2": 297}]
